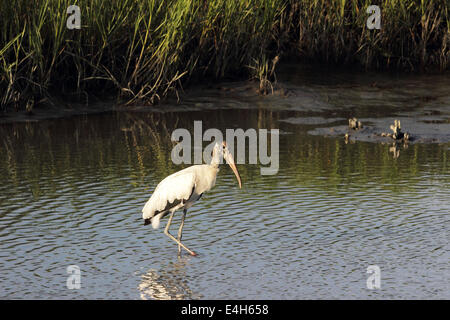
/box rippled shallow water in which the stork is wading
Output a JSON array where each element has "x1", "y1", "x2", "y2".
[{"x1": 0, "y1": 68, "x2": 450, "y2": 299}]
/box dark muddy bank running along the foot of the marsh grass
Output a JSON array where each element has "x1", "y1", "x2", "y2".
[{"x1": 0, "y1": 65, "x2": 450, "y2": 143}]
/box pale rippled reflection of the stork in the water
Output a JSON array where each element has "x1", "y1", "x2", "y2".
[{"x1": 138, "y1": 257, "x2": 201, "y2": 300}]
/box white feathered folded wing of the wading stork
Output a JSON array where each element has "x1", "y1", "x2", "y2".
[{"x1": 142, "y1": 170, "x2": 195, "y2": 219}]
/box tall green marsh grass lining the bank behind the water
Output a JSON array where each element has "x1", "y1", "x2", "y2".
[{"x1": 0, "y1": 0, "x2": 450, "y2": 111}]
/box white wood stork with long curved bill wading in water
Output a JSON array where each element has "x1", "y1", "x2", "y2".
[{"x1": 142, "y1": 142, "x2": 242, "y2": 256}]
